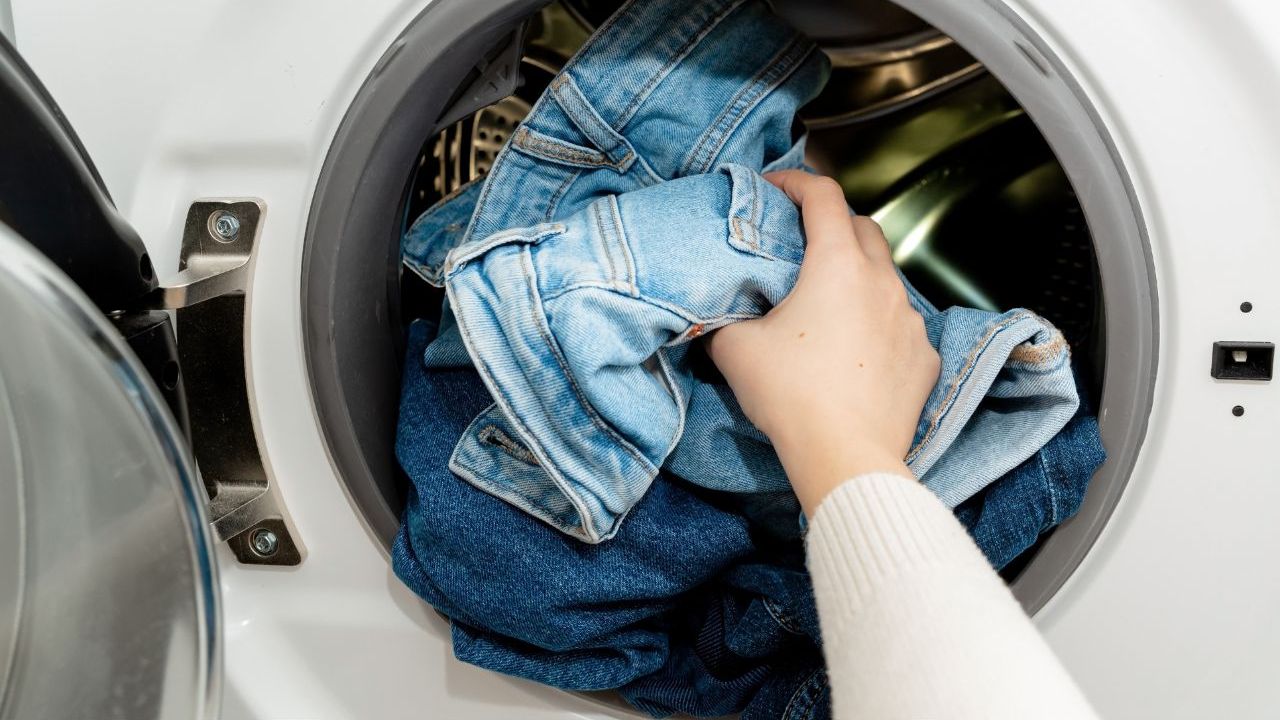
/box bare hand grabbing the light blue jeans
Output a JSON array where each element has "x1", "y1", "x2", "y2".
[{"x1": 707, "y1": 170, "x2": 940, "y2": 515}]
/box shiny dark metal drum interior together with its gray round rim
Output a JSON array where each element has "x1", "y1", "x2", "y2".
[{"x1": 302, "y1": 0, "x2": 1156, "y2": 611}]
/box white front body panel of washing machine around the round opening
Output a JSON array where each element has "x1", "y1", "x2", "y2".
[{"x1": 13, "y1": 0, "x2": 1280, "y2": 720}]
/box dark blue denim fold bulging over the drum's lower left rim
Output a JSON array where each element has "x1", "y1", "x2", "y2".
[{"x1": 392, "y1": 322, "x2": 755, "y2": 691}]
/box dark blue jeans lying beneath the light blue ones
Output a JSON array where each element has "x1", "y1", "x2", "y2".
[{"x1": 392, "y1": 322, "x2": 1102, "y2": 720}]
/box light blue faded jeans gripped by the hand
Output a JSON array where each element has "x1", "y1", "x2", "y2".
[{"x1": 403, "y1": 0, "x2": 1078, "y2": 543}]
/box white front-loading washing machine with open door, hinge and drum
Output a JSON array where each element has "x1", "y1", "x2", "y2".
[{"x1": 0, "y1": 0, "x2": 1280, "y2": 719}]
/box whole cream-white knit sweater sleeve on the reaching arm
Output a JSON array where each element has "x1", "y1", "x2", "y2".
[{"x1": 808, "y1": 474, "x2": 1096, "y2": 720}]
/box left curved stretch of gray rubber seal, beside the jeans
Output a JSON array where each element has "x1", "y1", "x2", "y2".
[{"x1": 302, "y1": 0, "x2": 547, "y2": 547}]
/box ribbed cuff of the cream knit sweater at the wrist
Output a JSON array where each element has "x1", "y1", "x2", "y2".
[{"x1": 808, "y1": 473, "x2": 991, "y2": 612}]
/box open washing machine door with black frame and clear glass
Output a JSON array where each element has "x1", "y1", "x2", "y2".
[{"x1": 0, "y1": 29, "x2": 220, "y2": 720}]
